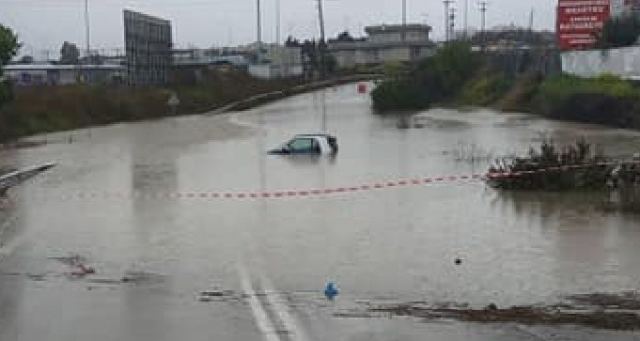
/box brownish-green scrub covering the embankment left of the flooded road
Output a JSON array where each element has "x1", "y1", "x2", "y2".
[{"x1": 0, "y1": 71, "x2": 302, "y2": 142}]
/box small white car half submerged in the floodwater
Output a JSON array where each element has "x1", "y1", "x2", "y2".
[{"x1": 269, "y1": 134, "x2": 338, "y2": 155}]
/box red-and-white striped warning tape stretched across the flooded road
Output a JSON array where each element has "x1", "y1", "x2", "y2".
[{"x1": 15, "y1": 161, "x2": 640, "y2": 200}]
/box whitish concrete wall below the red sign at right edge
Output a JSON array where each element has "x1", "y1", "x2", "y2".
[{"x1": 562, "y1": 46, "x2": 640, "y2": 80}]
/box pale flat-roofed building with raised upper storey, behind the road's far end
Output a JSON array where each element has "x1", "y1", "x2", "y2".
[{"x1": 328, "y1": 24, "x2": 436, "y2": 68}]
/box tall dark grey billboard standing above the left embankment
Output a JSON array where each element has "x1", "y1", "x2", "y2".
[{"x1": 124, "y1": 10, "x2": 173, "y2": 85}]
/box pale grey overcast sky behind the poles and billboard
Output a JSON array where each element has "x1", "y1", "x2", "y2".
[{"x1": 0, "y1": 0, "x2": 557, "y2": 55}]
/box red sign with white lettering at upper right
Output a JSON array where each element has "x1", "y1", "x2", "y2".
[{"x1": 556, "y1": 0, "x2": 611, "y2": 50}]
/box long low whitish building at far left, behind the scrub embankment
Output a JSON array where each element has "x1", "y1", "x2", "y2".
[{"x1": 3, "y1": 64, "x2": 127, "y2": 86}]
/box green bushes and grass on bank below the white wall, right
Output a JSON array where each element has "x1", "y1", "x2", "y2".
[{"x1": 372, "y1": 43, "x2": 640, "y2": 129}]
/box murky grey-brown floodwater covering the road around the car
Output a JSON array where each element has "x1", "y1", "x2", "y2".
[{"x1": 0, "y1": 85, "x2": 640, "y2": 341}]
